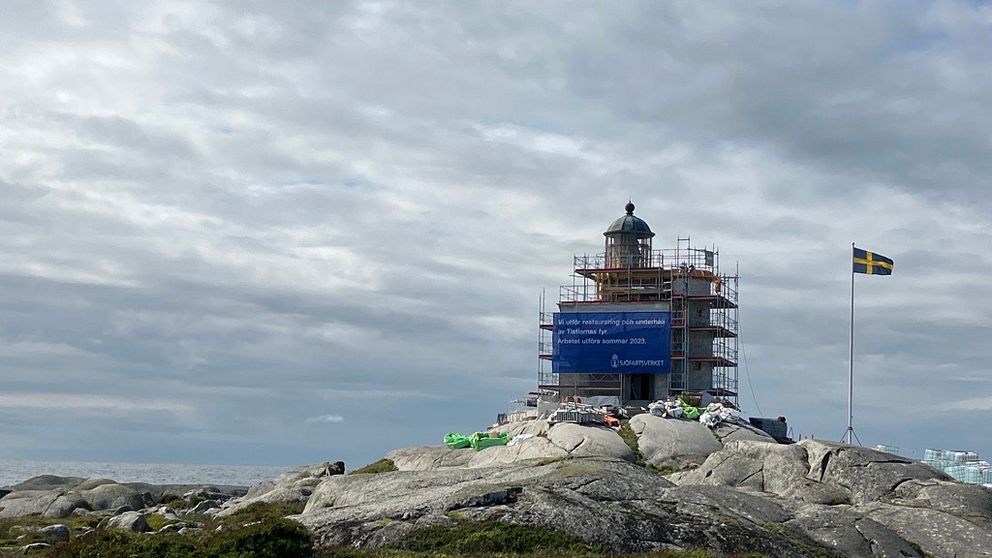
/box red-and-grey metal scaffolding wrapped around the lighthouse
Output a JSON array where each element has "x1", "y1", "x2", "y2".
[{"x1": 538, "y1": 235, "x2": 740, "y2": 404}]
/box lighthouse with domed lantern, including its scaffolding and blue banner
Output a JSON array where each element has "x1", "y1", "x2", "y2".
[{"x1": 538, "y1": 203, "x2": 739, "y2": 404}]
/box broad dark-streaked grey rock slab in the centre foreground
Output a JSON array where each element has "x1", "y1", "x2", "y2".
[{"x1": 295, "y1": 458, "x2": 813, "y2": 558}]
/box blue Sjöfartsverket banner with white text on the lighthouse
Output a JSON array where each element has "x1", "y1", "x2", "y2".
[{"x1": 551, "y1": 312, "x2": 672, "y2": 374}]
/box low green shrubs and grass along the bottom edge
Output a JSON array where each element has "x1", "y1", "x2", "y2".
[{"x1": 0, "y1": 502, "x2": 763, "y2": 558}]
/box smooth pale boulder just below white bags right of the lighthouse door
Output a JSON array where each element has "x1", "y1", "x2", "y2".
[{"x1": 630, "y1": 414, "x2": 723, "y2": 469}]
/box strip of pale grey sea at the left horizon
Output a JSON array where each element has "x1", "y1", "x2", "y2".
[{"x1": 0, "y1": 459, "x2": 295, "y2": 487}]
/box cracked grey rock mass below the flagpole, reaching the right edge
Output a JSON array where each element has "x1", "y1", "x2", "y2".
[{"x1": 669, "y1": 440, "x2": 992, "y2": 557}]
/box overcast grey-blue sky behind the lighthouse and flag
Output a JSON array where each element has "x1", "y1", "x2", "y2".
[{"x1": 0, "y1": 0, "x2": 992, "y2": 466}]
